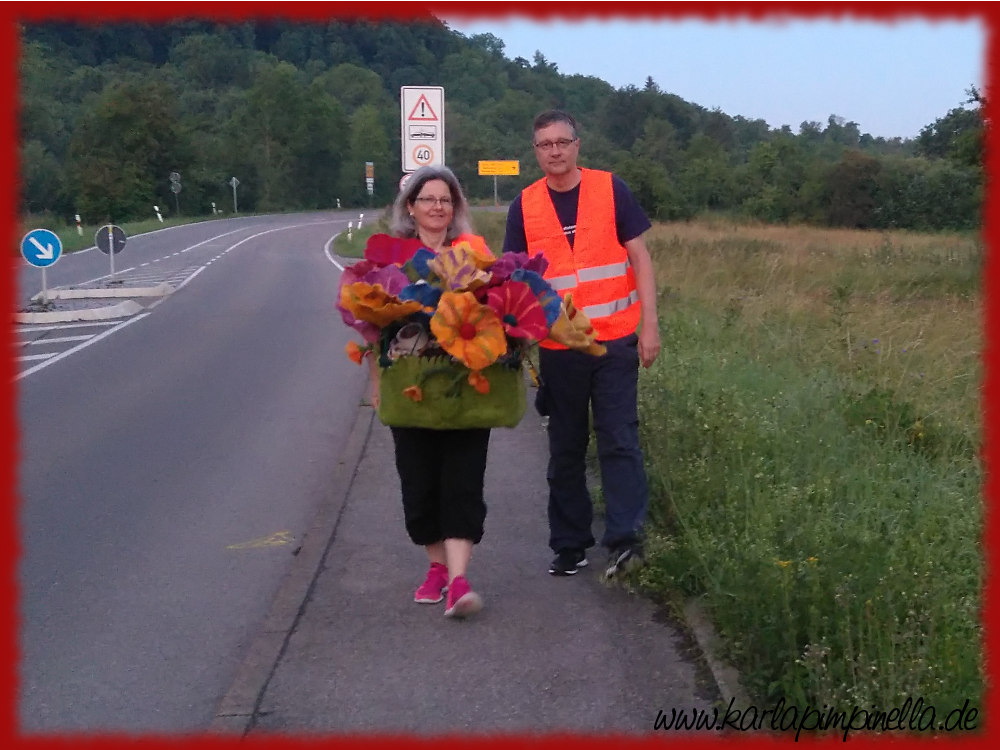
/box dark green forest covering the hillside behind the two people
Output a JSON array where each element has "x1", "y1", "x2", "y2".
[{"x1": 19, "y1": 18, "x2": 986, "y2": 230}]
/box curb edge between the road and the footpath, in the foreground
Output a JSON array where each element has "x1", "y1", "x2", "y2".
[{"x1": 208, "y1": 407, "x2": 375, "y2": 736}]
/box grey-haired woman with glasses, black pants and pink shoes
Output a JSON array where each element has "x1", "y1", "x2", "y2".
[{"x1": 369, "y1": 167, "x2": 490, "y2": 617}]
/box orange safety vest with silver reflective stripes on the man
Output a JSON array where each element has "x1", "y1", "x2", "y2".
[{"x1": 521, "y1": 169, "x2": 641, "y2": 349}]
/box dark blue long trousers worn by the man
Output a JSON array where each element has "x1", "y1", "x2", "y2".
[{"x1": 537, "y1": 334, "x2": 648, "y2": 552}]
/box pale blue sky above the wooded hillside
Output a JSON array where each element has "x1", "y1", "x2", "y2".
[{"x1": 440, "y1": 13, "x2": 988, "y2": 138}]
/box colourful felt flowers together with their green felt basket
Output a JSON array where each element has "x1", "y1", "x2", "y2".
[{"x1": 337, "y1": 234, "x2": 604, "y2": 429}]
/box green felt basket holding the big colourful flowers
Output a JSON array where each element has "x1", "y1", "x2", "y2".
[{"x1": 378, "y1": 357, "x2": 527, "y2": 430}]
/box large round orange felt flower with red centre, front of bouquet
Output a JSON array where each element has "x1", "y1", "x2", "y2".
[{"x1": 431, "y1": 292, "x2": 507, "y2": 370}]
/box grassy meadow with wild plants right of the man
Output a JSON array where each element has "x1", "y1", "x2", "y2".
[{"x1": 476, "y1": 215, "x2": 985, "y2": 717}]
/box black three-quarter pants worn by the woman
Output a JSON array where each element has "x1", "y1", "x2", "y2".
[{"x1": 391, "y1": 427, "x2": 490, "y2": 546}]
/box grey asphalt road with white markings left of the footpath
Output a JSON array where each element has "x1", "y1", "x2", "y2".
[{"x1": 16, "y1": 211, "x2": 365, "y2": 733}]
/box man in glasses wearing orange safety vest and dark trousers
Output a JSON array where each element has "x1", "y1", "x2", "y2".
[{"x1": 503, "y1": 110, "x2": 660, "y2": 577}]
